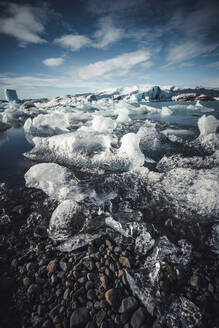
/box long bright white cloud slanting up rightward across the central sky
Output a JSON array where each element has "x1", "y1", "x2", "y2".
[{"x1": 78, "y1": 50, "x2": 150, "y2": 80}]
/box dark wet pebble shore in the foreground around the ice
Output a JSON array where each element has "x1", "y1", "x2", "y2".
[{"x1": 0, "y1": 184, "x2": 219, "y2": 328}]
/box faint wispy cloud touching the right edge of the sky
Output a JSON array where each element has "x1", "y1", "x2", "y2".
[{"x1": 165, "y1": 40, "x2": 217, "y2": 66}]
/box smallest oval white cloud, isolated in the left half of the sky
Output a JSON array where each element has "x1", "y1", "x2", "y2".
[{"x1": 54, "y1": 34, "x2": 91, "y2": 51}]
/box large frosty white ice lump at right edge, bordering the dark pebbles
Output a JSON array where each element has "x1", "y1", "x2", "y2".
[{"x1": 156, "y1": 167, "x2": 219, "y2": 221}]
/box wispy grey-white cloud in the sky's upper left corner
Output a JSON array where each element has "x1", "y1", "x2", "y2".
[{"x1": 0, "y1": 3, "x2": 46, "y2": 45}]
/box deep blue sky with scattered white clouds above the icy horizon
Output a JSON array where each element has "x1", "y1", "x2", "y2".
[{"x1": 0, "y1": 0, "x2": 219, "y2": 98}]
